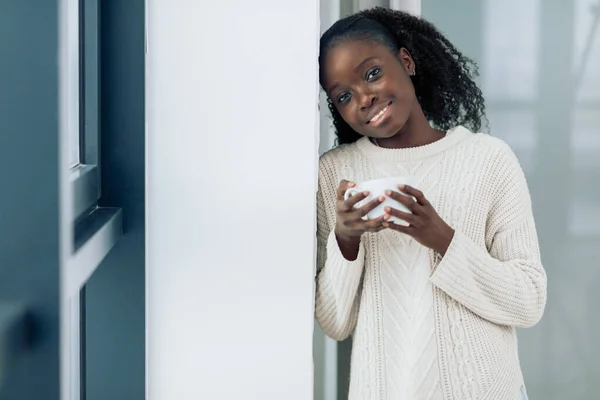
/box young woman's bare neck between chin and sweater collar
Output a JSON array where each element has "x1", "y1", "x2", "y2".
[{"x1": 377, "y1": 106, "x2": 446, "y2": 149}]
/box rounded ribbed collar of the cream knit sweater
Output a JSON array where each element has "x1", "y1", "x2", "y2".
[{"x1": 356, "y1": 126, "x2": 473, "y2": 162}]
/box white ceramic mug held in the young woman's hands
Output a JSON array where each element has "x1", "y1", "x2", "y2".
[{"x1": 344, "y1": 176, "x2": 412, "y2": 226}]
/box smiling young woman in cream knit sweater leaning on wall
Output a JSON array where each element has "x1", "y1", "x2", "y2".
[{"x1": 316, "y1": 8, "x2": 546, "y2": 400}]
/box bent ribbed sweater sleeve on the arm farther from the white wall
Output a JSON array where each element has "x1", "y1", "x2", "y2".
[{"x1": 431, "y1": 147, "x2": 546, "y2": 328}]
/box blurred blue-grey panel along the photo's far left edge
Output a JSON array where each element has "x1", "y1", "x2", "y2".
[{"x1": 0, "y1": 0, "x2": 59, "y2": 400}]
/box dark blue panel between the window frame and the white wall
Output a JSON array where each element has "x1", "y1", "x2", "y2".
[{"x1": 86, "y1": 0, "x2": 145, "y2": 400}]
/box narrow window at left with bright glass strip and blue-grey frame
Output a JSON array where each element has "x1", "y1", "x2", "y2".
[{"x1": 61, "y1": 0, "x2": 122, "y2": 400}]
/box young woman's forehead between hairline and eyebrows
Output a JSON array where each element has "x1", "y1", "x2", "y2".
[{"x1": 322, "y1": 40, "x2": 393, "y2": 87}]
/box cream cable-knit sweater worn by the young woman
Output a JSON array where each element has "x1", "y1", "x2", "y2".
[{"x1": 315, "y1": 127, "x2": 546, "y2": 400}]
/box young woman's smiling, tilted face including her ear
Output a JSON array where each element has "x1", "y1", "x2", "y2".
[{"x1": 322, "y1": 40, "x2": 418, "y2": 138}]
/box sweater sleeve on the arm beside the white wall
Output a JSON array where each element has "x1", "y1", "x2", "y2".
[{"x1": 315, "y1": 169, "x2": 365, "y2": 340}]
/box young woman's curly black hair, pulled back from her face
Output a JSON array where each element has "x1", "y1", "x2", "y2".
[{"x1": 319, "y1": 7, "x2": 485, "y2": 144}]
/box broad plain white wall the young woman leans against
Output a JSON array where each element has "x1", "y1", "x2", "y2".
[{"x1": 146, "y1": 0, "x2": 319, "y2": 400}]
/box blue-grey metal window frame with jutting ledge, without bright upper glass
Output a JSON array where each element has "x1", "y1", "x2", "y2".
[{"x1": 69, "y1": 0, "x2": 123, "y2": 400}]
